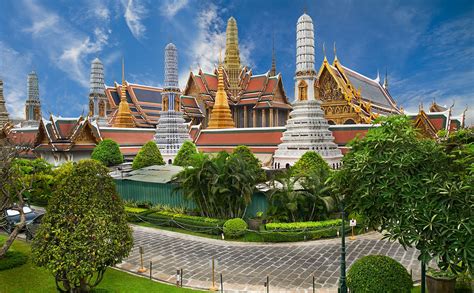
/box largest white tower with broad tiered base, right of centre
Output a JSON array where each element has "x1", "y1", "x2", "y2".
[{"x1": 273, "y1": 13, "x2": 342, "y2": 168}]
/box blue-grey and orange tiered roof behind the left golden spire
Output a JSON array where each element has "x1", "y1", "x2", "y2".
[{"x1": 105, "y1": 82, "x2": 163, "y2": 128}]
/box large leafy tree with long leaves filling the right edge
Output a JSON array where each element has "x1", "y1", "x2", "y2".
[{"x1": 332, "y1": 116, "x2": 474, "y2": 272}]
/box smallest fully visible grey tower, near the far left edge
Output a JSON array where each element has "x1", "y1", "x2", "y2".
[{"x1": 23, "y1": 71, "x2": 41, "y2": 127}]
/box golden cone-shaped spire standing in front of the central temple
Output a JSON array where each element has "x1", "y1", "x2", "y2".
[{"x1": 207, "y1": 62, "x2": 235, "y2": 129}]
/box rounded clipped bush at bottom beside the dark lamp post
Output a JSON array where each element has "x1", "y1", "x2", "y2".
[{"x1": 347, "y1": 255, "x2": 413, "y2": 293}]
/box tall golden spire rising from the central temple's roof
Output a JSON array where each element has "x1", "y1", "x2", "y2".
[{"x1": 224, "y1": 17, "x2": 241, "y2": 96}]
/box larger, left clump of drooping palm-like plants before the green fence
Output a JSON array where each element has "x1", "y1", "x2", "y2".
[{"x1": 176, "y1": 152, "x2": 258, "y2": 219}]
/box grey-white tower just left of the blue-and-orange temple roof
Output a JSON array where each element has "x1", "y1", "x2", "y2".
[{"x1": 89, "y1": 58, "x2": 107, "y2": 126}]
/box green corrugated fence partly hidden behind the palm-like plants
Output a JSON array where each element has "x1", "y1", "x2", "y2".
[{"x1": 115, "y1": 179, "x2": 268, "y2": 217}]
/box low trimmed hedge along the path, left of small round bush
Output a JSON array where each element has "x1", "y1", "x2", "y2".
[{"x1": 144, "y1": 211, "x2": 225, "y2": 235}]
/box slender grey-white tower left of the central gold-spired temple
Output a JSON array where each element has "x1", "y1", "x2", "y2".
[{"x1": 155, "y1": 43, "x2": 190, "y2": 163}]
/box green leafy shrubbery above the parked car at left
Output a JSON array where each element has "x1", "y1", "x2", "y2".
[{"x1": 14, "y1": 159, "x2": 55, "y2": 205}]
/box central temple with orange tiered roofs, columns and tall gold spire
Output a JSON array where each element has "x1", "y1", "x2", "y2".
[{"x1": 181, "y1": 17, "x2": 291, "y2": 128}]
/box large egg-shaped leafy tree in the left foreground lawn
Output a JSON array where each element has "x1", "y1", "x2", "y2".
[{"x1": 32, "y1": 160, "x2": 133, "y2": 292}]
